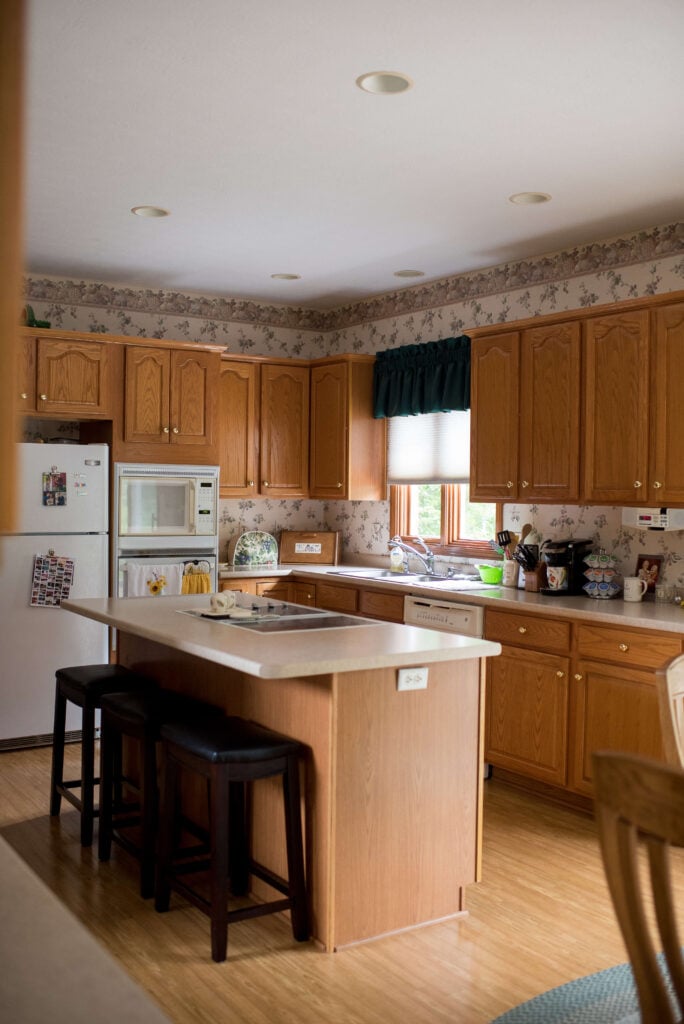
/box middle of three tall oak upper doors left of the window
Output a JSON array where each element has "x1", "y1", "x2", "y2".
[{"x1": 259, "y1": 364, "x2": 309, "y2": 498}]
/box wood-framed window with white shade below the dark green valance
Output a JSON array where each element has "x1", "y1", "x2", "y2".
[{"x1": 387, "y1": 412, "x2": 502, "y2": 558}]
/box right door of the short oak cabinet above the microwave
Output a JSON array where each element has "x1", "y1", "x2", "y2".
[{"x1": 170, "y1": 351, "x2": 218, "y2": 444}]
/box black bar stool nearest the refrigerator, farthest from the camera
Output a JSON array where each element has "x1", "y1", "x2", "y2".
[{"x1": 50, "y1": 665, "x2": 156, "y2": 846}]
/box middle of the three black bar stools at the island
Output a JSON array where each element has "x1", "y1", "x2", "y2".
[{"x1": 97, "y1": 689, "x2": 218, "y2": 899}]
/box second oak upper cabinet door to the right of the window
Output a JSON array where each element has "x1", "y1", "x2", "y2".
[{"x1": 518, "y1": 321, "x2": 581, "y2": 503}]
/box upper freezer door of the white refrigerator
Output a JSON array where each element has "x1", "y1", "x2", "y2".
[{"x1": 16, "y1": 443, "x2": 110, "y2": 534}]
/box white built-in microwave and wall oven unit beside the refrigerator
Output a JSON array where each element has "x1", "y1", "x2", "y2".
[{"x1": 112, "y1": 463, "x2": 218, "y2": 597}]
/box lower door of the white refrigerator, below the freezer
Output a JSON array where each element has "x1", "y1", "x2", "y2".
[{"x1": 0, "y1": 532, "x2": 109, "y2": 746}]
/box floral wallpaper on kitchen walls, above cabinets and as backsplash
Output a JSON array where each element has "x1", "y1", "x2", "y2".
[{"x1": 25, "y1": 224, "x2": 684, "y2": 591}]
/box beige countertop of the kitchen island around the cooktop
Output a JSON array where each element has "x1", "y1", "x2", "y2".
[{"x1": 61, "y1": 594, "x2": 501, "y2": 679}]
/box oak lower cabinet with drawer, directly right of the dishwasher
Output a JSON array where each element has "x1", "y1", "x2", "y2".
[{"x1": 484, "y1": 609, "x2": 570, "y2": 786}]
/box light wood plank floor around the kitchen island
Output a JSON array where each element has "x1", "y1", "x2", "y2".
[{"x1": 0, "y1": 746, "x2": 684, "y2": 1024}]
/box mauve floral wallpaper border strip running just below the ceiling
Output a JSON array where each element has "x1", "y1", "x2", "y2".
[{"x1": 25, "y1": 222, "x2": 684, "y2": 329}]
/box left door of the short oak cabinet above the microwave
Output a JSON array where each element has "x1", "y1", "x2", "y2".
[{"x1": 124, "y1": 346, "x2": 171, "y2": 444}]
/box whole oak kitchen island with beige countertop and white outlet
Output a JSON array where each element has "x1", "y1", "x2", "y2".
[{"x1": 62, "y1": 595, "x2": 501, "y2": 950}]
